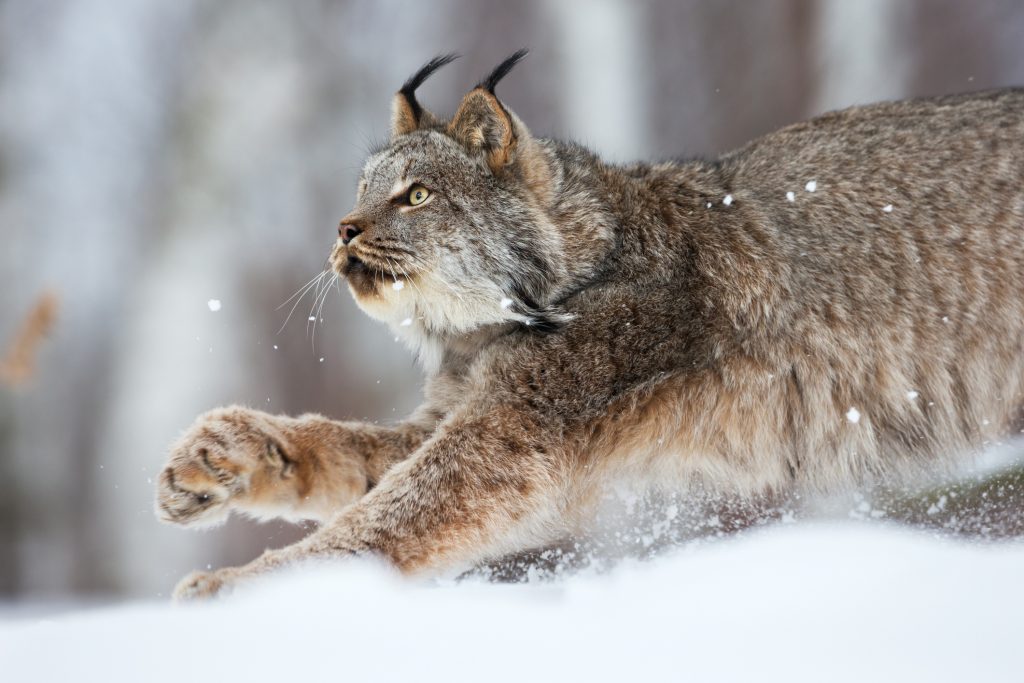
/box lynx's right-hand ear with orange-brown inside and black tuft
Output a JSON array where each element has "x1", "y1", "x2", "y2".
[{"x1": 447, "y1": 50, "x2": 528, "y2": 174}]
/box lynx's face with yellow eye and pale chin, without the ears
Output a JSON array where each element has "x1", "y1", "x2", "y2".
[{"x1": 332, "y1": 130, "x2": 556, "y2": 333}]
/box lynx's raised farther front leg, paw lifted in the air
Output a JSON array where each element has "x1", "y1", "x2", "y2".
[{"x1": 157, "y1": 408, "x2": 426, "y2": 525}]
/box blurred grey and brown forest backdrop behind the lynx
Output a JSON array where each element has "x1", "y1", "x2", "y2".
[{"x1": 0, "y1": 0, "x2": 1024, "y2": 599}]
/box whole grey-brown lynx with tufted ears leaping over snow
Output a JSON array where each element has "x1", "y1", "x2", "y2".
[{"x1": 158, "y1": 52, "x2": 1024, "y2": 597}]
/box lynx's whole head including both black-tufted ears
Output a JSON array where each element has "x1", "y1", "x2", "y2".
[{"x1": 331, "y1": 50, "x2": 585, "y2": 368}]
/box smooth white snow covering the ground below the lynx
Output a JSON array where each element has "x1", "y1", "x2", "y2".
[{"x1": 0, "y1": 522, "x2": 1024, "y2": 683}]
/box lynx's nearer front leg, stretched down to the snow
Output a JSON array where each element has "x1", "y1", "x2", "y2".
[{"x1": 175, "y1": 415, "x2": 565, "y2": 599}]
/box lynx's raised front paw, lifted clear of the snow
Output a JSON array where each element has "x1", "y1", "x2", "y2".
[{"x1": 157, "y1": 407, "x2": 319, "y2": 526}]
